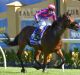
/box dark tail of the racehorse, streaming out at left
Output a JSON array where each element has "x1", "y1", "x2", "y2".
[{"x1": 3, "y1": 33, "x2": 19, "y2": 46}]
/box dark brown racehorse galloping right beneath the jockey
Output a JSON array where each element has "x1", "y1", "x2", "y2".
[{"x1": 2, "y1": 14, "x2": 79, "y2": 72}]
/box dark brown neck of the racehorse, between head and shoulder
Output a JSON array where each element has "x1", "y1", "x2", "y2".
[{"x1": 45, "y1": 21, "x2": 66, "y2": 38}]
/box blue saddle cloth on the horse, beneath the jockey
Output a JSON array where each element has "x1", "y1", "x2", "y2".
[{"x1": 30, "y1": 26, "x2": 47, "y2": 45}]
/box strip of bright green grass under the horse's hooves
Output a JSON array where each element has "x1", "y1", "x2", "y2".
[{"x1": 0, "y1": 67, "x2": 80, "y2": 75}]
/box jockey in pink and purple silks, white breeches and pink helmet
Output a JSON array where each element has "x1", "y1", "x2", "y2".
[{"x1": 31, "y1": 4, "x2": 56, "y2": 44}]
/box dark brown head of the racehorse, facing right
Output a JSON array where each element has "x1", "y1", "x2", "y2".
[{"x1": 62, "y1": 13, "x2": 79, "y2": 30}]
